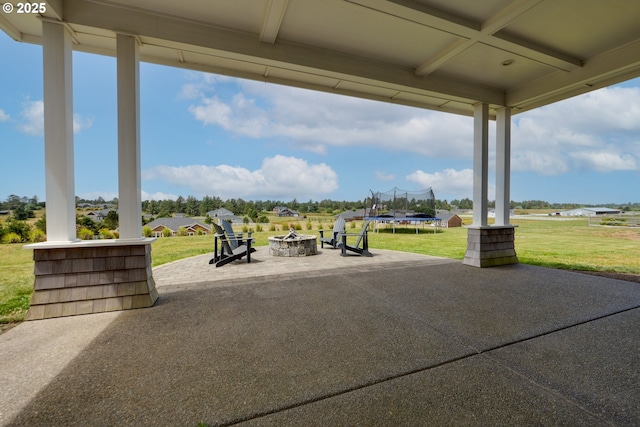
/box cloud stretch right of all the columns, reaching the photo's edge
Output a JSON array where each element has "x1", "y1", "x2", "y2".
[{"x1": 512, "y1": 87, "x2": 640, "y2": 175}]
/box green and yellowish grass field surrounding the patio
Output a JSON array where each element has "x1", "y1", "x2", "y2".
[{"x1": 0, "y1": 217, "x2": 640, "y2": 324}]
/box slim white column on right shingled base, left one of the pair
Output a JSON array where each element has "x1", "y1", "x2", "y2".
[{"x1": 473, "y1": 103, "x2": 489, "y2": 227}]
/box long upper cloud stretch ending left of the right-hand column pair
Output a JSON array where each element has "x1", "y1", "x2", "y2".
[{"x1": 182, "y1": 76, "x2": 473, "y2": 158}]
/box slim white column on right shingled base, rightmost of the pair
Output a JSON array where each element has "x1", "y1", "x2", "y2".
[{"x1": 495, "y1": 107, "x2": 511, "y2": 225}]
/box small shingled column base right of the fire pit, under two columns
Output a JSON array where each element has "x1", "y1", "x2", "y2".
[{"x1": 462, "y1": 226, "x2": 518, "y2": 267}]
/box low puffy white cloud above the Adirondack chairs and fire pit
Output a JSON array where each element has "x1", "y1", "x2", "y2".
[{"x1": 142, "y1": 155, "x2": 338, "y2": 199}]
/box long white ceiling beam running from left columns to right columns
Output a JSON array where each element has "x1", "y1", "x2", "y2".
[{"x1": 64, "y1": 0, "x2": 504, "y2": 105}]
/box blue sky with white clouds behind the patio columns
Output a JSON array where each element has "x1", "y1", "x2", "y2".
[{"x1": 0, "y1": 31, "x2": 640, "y2": 204}]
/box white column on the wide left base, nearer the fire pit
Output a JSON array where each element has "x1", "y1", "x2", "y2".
[{"x1": 117, "y1": 34, "x2": 142, "y2": 239}]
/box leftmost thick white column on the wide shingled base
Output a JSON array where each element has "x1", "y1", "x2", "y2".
[{"x1": 42, "y1": 21, "x2": 77, "y2": 242}]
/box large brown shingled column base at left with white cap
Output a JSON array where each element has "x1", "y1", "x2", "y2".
[{"x1": 26, "y1": 239, "x2": 158, "y2": 320}]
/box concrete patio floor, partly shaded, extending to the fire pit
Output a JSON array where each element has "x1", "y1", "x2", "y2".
[{"x1": 0, "y1": 248, "x2": 640, "y2": 426}]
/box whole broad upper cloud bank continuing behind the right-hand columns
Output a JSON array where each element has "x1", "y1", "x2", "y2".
[{"x1": 183, "y1": 75, "x2": 640, "y2": 179}]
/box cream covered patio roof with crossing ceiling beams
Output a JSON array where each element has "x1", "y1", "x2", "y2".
[{"x1": 0, "y1": 0, "x2": 640, "y2": 117}]
